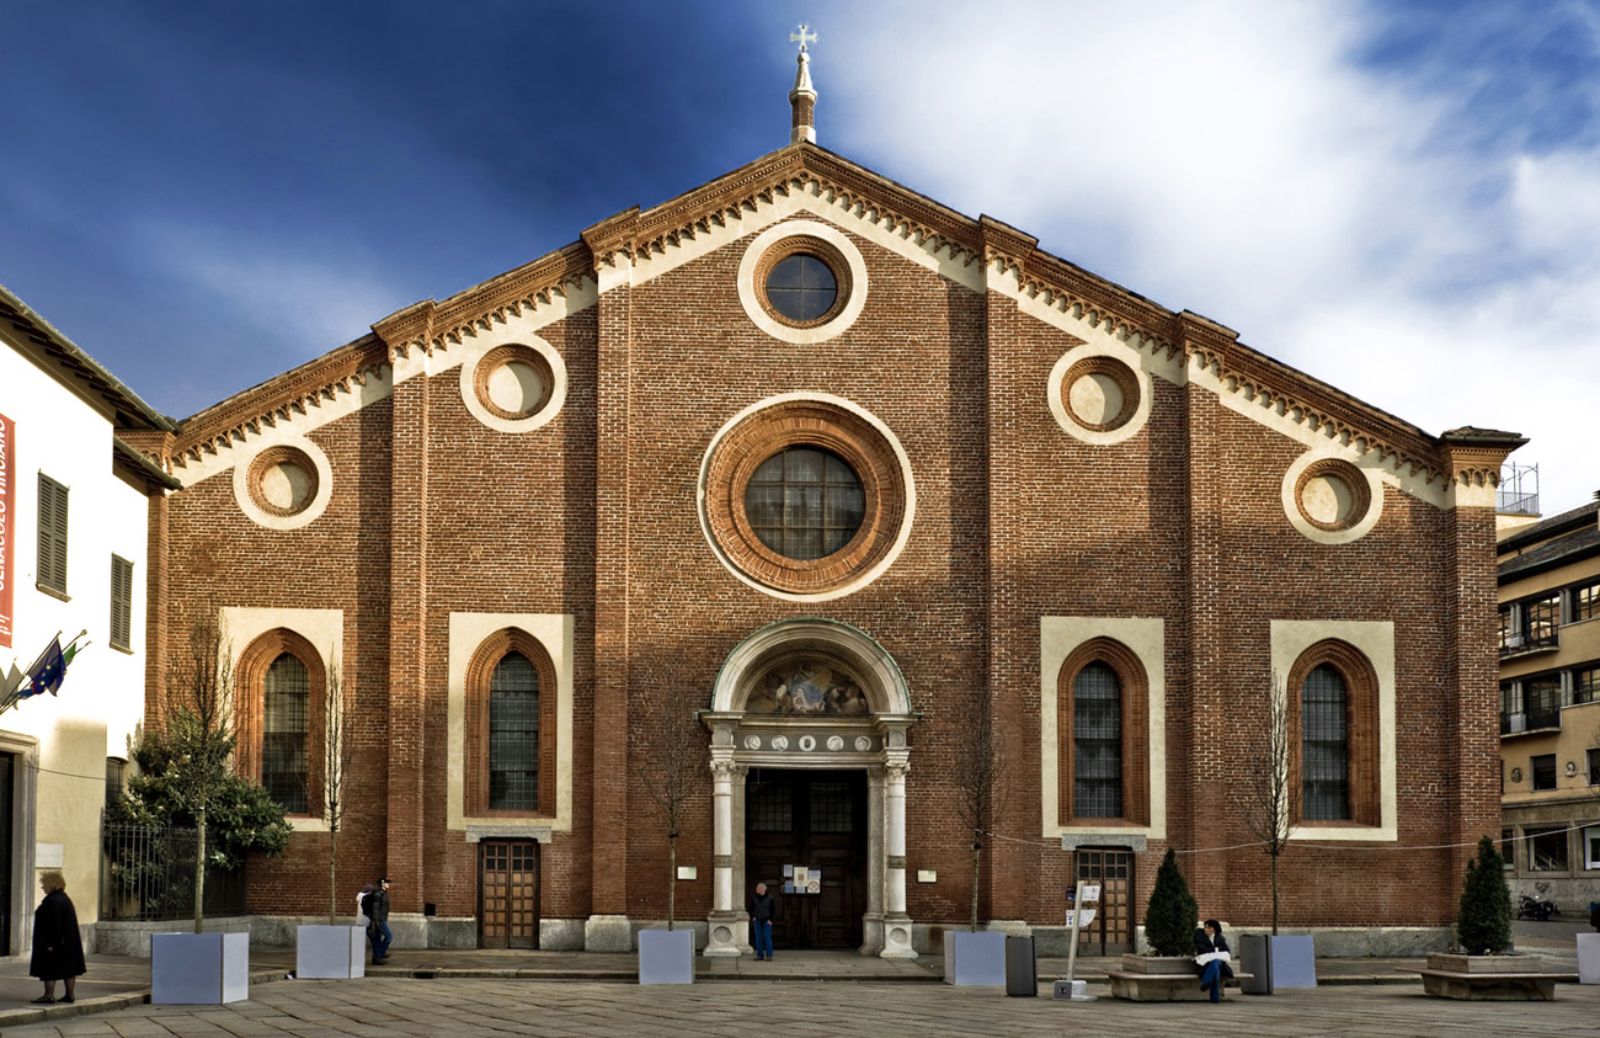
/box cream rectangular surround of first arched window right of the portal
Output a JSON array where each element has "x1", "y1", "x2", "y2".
[{"x1": 1038, "y1": 616, "x2": 1166, "y2": 846}]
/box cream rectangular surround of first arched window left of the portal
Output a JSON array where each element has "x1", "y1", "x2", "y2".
[{"x1": 445, "y1": 613, "x2": 574, "y2": 843}]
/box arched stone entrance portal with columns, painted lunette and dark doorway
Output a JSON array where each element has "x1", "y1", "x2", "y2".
[{"x1": 701, "y1": 619, "x2": 917, "y2": 958}]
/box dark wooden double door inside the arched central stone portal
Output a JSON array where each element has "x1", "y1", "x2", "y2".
[{"x1": 744, "y1": 768, "x2": 867, "y2": 948}]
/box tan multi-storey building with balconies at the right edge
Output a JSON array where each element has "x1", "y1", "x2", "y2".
[{"x1": 1498, "y1": 494, "x2": 1600, "y2": 912}]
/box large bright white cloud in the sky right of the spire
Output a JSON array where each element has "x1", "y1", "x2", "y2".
[{"x1": 814, "y1": 3, "x2": 1600, "y2": 512}]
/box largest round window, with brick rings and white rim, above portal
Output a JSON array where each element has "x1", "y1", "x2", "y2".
[{"x1": 706, "y1": 400, "x2": 909, "y2": 595}]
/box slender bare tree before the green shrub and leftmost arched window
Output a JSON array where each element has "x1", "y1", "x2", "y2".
[{"x1": 168, "y1": 609, "x2": 234, "y2": 934}]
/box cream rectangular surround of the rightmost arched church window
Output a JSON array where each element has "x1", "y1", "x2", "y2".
[{"x1": 1270, "y1": 621, "x2": 1400, "y2": 843}]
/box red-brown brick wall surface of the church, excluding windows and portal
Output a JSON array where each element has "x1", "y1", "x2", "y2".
[{"x1": 152, "y1": 215, "x2": 1498, "y2": 924}]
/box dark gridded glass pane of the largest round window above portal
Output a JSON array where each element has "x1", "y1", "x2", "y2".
[{"x1": 744, "y1": 446, "x2": 866, "y2": 560}]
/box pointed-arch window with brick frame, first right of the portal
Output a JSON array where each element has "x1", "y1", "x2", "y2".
[{"x1": 1056, "y1": 638, "x2": 1150, "y2": 825}]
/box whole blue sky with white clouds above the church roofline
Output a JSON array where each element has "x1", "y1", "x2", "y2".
[{"x1": 0, "y1": 0, "x2": 1600, "y2": 513}]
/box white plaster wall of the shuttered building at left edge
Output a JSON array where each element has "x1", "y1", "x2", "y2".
[{"x1": 0, "y1": 336, "x2": 149, "y2": 923}]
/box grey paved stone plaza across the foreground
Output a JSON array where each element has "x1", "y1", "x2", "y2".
[{"x1": 6, "y1": 977, "x2": 1600, "y2": 1038}]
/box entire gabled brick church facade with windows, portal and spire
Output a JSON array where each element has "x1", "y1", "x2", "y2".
[{"x1": 128, "y1": 64, "x2": 1520, "y2": 956}]
